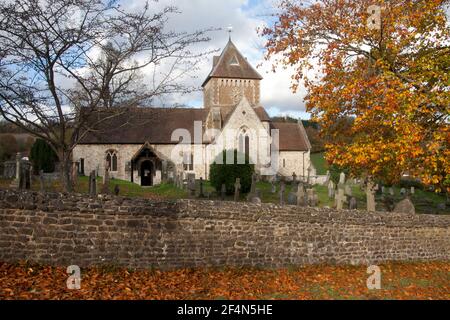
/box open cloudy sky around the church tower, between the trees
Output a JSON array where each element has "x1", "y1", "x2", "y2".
[{"x1": 118, "y1": 0, "x2": 310, "y2": 119}]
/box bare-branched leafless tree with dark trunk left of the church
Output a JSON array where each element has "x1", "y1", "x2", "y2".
[{"x1": 0, "y1": 0, "x2": 213, "y2": 191}]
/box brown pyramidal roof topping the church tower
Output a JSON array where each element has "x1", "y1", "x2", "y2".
[{"x1": 202, "y1": 39, "x2": 262, "y2": 86}]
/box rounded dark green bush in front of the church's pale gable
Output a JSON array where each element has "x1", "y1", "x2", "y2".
[{"x1": 209, "y1": 150, "x2": 255, "y2": 195}]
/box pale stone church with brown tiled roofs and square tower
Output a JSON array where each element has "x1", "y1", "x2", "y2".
[{"x1": 73, "y1": 39, "x2": 311, "y2": 186}]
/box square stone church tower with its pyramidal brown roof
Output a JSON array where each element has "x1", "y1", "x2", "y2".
[{"x1": 202, "y1": 39, "x2": 262, "y2": 109}]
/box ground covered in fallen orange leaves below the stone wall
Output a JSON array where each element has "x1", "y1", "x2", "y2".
[{"x1": 0, "y1": 262, "x2": 450, "y2": 300}]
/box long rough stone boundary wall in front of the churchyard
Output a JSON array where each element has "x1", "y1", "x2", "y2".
[{"x1": 0, "y1": 190, "x2": 450, "y2": 269}]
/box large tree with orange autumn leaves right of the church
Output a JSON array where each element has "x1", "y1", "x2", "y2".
[{"x1": 261, "y1": 0, "x2": 450, "y2": 190}]
